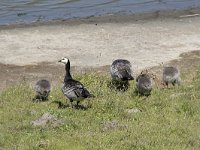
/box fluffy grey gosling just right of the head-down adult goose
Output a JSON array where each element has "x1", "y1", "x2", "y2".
[{"x1": 136, "y1": 72, "x2": 153, "y2": 96}]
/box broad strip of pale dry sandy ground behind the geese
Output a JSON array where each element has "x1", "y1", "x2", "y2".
[{"x1": 0, "y1": 10, "x2": 200, "y2": 90}]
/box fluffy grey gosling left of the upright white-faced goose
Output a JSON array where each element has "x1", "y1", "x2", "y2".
[{"x1": 33, "y1": 79, "x2": 51, "y2": 101}]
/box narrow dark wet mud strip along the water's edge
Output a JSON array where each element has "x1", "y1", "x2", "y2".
[{"x1": 0, "y1": 8, "x2": 200, "y2": 30}]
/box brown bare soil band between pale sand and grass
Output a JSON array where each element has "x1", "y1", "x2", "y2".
[{"x1": 0, "y1": 50, "x2": 200, "y2": 91}]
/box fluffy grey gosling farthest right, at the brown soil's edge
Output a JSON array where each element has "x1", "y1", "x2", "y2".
[{"x1": 163, "y1": 67, "x2": 181, "y2": 87}]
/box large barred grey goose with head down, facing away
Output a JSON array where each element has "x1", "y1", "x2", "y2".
[{"x1": 110, "y1": 59, "x2": 134, "y2": 91}]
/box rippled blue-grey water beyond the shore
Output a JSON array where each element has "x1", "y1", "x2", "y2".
[{"x1": 0, "y1": 0, "x2": 200, "y2": 25}]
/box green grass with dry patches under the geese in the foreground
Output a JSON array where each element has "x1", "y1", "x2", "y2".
[{"x1": 0, "y1": 69, "x2": 200, "y2": 150}]
